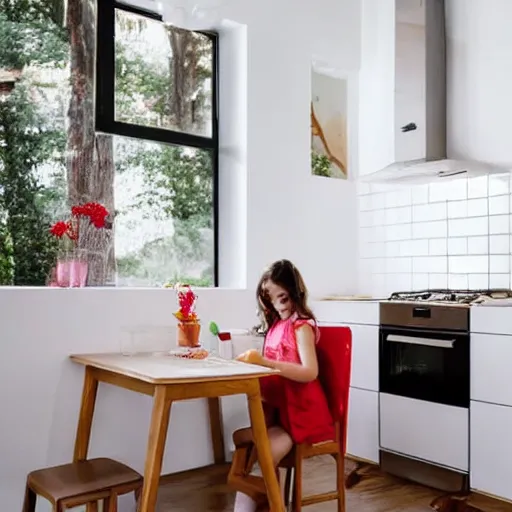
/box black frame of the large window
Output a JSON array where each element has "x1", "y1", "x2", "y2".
[{"x1": 95, "y1": 0, "x2": 219, "y2": 287}]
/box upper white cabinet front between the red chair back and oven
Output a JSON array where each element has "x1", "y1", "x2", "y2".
[{"x1": 348, "y1": 325, "x2": 379, "y2": 391}]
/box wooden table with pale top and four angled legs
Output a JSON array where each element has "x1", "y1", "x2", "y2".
[{"x1": 71, "y1": 354, "x2": 285, "y2": 512}]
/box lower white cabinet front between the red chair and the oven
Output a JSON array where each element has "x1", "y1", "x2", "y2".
[{"x1": 347, "y1": 388, "x2": 379, "y2": 464}]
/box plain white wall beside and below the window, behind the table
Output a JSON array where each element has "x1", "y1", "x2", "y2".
[{"x1": 0, "y1": 0, "x2": 360, "y2": 511}]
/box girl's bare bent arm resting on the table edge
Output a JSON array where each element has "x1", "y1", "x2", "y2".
[{"x1": 261, "y1": 324, "x2": 318, "y2": 382}]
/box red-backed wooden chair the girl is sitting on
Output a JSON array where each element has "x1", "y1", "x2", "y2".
[{"x1": 279, "y1": 327, "x2": 352, "y2": 512}]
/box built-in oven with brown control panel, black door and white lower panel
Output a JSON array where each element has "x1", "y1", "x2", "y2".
[{"x1": 379, "y1": 302, "x2": 470, "y2": 491}]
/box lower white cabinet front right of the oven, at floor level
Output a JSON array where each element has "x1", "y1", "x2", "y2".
[{"x1": 470, "y1": 402, "x2": 512, "y2": 500}]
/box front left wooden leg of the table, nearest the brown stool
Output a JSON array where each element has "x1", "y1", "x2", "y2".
[{"x1": 139, "y1": 386, "x2": 172, "y2": 512}]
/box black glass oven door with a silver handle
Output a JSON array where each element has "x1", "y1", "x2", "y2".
[{"x1": 379, "y1": 326, "x2": 469, "y2": 407}]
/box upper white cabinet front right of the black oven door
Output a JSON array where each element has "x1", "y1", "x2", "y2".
[{"x1": 471, "y1": 334, "x2": 512, "y2": 406}]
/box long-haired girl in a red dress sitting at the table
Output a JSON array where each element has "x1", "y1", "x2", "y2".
[{"x1": 235, "y1": 260, "x2": 334, "y2": 512}]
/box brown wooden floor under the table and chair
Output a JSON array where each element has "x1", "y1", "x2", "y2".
[{"x1": 157, "y1": 458, "x2": 512, "y2": 512}]
